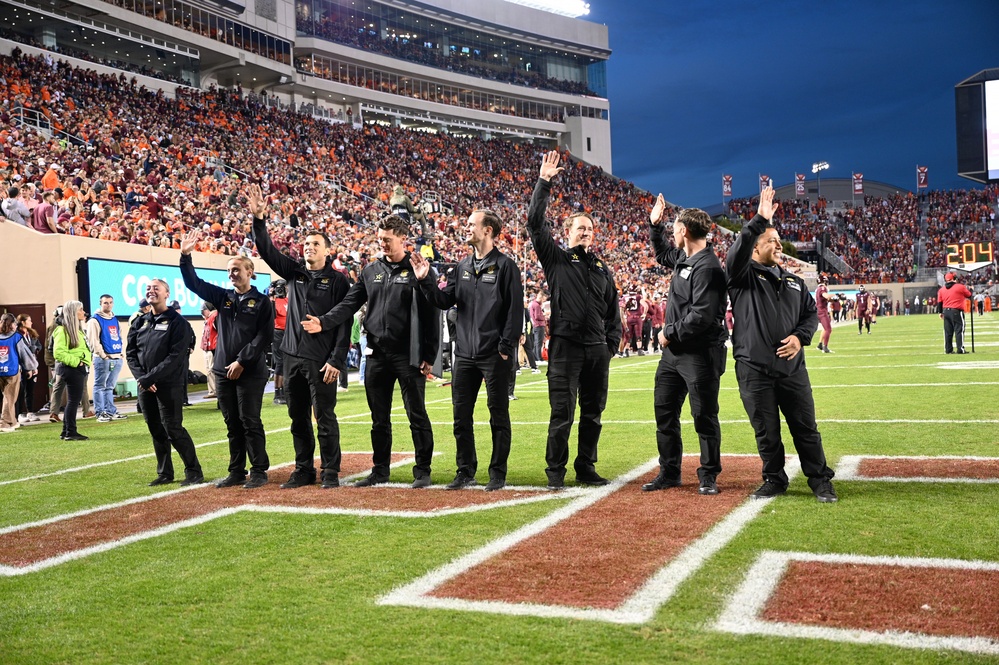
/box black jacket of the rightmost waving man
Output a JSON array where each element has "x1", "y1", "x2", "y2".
[{"x1": 725, "y1": 215, "x2": 819, "y2": 376}]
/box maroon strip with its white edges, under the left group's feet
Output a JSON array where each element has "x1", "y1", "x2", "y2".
[{"x1": 0, "y1": 453, "x2": 587, "y2": 577}]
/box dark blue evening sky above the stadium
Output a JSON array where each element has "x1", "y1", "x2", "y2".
[{"x1": 586, "y1": 0, "x2": 999, "y2": 207}]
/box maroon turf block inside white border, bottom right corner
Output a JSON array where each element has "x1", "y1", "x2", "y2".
[{"x1": 760, "y1": 561, "x2": 999, "y2": 639}]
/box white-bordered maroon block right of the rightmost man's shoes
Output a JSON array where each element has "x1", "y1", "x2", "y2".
[{"x1": 836, "y1": 455, "x2": 999, "y2": 484}]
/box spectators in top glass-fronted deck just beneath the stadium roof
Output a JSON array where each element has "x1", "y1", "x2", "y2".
[{"x1": 296, "y1": 14, "x2": 596, "y2": 95}]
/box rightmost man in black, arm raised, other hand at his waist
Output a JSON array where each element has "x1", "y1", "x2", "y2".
[{"x1": 725, "y1": 187, "x2": 838, "y2": 503}]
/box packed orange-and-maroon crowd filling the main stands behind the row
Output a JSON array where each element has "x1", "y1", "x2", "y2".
[{"x1": 0, "y1": 52, "x2": 996, "y2": 294}]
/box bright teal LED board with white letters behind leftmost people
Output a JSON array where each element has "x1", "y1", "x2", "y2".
[{"x1": 76, "y1": 258, "x2": 271, "y2": 319}]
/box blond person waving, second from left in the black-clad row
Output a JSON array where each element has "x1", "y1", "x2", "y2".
[{"x1": 180, "y1": 230, "x2": 274, "y2": 489}]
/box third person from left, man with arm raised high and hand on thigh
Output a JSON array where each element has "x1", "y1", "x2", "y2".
[{"x1": 247, "y1": 185, "x2": 350, "y2": 489}]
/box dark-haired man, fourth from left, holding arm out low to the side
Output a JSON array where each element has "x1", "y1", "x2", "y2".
[{"x1": 303, "y1": 215, "x2": 441, "y2": 488}]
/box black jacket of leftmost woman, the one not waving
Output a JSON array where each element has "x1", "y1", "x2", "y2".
[{"x1": 125, "y1": 308, "x2": 194, "y2": 388}]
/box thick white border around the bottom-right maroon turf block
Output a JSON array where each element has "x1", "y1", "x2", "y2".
[{"x1": 714, "y1": 551, "x2": 999, "y2": 655}]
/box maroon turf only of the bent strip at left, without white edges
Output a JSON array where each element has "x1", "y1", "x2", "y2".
[{"x1": 0, "y1": 454, "x2": 537, "y2": 567}]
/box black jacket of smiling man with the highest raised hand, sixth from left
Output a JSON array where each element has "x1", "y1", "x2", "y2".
[{"x1": 527, "y1": 178, "x2": 621, "y2": 354}]
